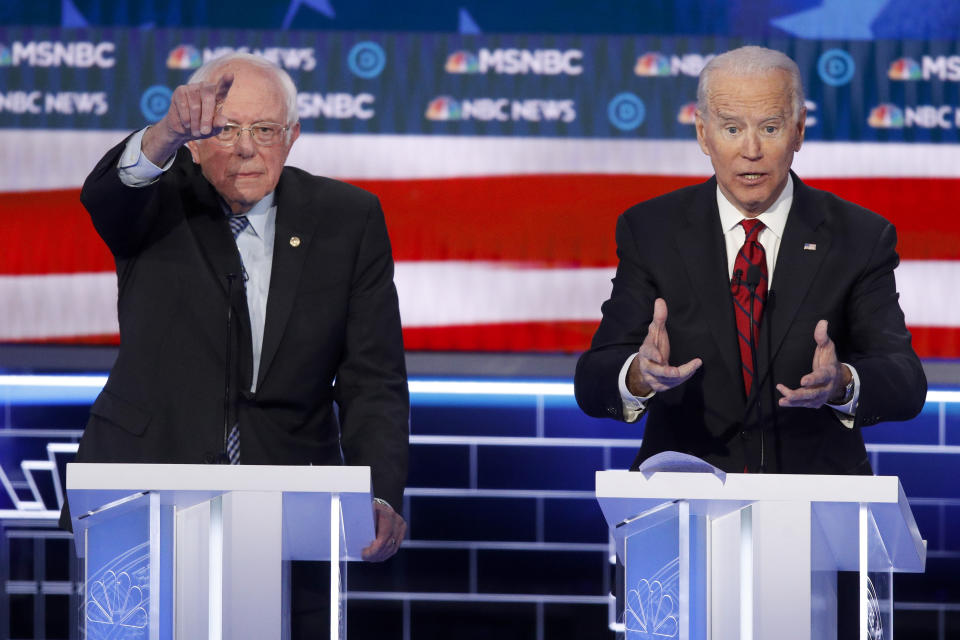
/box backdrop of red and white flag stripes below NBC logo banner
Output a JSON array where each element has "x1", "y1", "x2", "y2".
[{"x1": 0, "y1": 30, "x2": 960, "y2": 358}]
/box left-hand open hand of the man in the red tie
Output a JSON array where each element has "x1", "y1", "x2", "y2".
[{"x1": 627, "y1": 298, "x2": 703, "y2": 397}]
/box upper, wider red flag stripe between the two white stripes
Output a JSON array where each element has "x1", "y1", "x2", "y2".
[{"x1": 0, "y1": 175, "x2": 960, "y2": 275}]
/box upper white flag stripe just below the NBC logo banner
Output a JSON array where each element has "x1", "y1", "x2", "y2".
[{"x1": 0, "y1": 129, "x2": 960, "y2": 191}]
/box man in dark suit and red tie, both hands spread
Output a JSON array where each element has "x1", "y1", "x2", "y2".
[{"x1": 575, "y1": 47, "x2": 926, "y2": 474}]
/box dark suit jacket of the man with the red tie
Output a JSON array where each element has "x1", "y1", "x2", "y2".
[{"x1": 575, "y1": 176, "x2": 926, "y2": 474}]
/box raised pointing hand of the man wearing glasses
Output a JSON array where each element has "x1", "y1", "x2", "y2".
[{"x1": 140, "y1": 73, "x2": 233, "y2": 167}]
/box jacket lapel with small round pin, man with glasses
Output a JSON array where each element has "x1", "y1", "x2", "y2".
[{"x1": 257, "y1": 171, "x2": 319, "y2": 389}]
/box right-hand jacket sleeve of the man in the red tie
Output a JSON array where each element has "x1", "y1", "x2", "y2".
[{"x1": 838, "y1": 223, "x2": 927, "y2": 426}]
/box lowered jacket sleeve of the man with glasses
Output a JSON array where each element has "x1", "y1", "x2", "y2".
[{"x1": 335, "y1": 198, "x2": 410, "y2": 512}]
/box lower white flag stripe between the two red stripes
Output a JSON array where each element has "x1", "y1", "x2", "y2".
[{"x1": 0, "y1": 260, "x2": 960, "y2": 340}]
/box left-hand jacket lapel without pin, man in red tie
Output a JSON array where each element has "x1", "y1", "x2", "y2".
[{"x1": 677, "y1": 178, "x2": 741, "y2": 376}]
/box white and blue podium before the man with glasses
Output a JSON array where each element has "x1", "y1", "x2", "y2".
[{"x1": 67, "y1": 463, "x2": 374, "y2": 640}]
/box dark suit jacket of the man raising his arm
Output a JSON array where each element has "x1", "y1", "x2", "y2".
[{"x1": 70, "y1": 142, "x2": 409, "y2": 511}]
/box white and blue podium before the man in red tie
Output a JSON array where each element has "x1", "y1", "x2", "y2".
[{"x1": 596, "y1": 464, "x2": 926, "y2": 640}]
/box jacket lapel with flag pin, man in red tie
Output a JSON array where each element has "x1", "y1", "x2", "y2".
[{"x1": 757, "y1": 172, "x2": 832, "y2": 382}]
